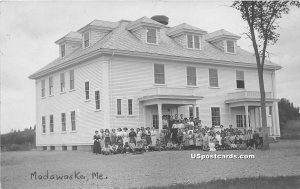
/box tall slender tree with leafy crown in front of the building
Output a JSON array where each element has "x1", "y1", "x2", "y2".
[{"x1": 232, "y1": 1, "x2": 300, "y2": 150}]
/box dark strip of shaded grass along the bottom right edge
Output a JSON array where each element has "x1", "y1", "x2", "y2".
[{"x1": 137, "y1": 175, "x2": 300, "y2": 189}]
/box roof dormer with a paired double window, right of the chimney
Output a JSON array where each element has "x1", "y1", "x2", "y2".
[{"x1": 167, "y1": 23, "x2": 207, "y2": 50}]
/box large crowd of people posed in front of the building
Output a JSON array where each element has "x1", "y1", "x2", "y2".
[{"x1": 94, "y1": 116, "x2": 263, "y2": 155}]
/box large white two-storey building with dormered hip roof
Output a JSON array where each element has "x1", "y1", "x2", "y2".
[{"x1": 29, "y1": 16, "x2": 281, "y2": 150}]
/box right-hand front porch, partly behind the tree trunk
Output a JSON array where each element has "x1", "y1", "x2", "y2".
[{"x1": 225, "y1": 91, "x2": 280, "y2": 136}]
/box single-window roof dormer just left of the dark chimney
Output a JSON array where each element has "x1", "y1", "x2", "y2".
[{"x1": 127, "y1": 17, "x2": 165, "y2": 45}]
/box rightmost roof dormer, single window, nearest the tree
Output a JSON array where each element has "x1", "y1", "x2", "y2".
[{"x1": 206, "y1": 29, "x2": 241, "y2": 54}]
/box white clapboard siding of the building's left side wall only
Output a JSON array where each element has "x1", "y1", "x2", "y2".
[{"x1": 37, "y1": 58, "x2": 106, "y2": 146}]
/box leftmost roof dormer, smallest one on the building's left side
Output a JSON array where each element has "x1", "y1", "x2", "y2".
[{"x1": 55, "y1": 32, "x2": 82, "y2": 58}]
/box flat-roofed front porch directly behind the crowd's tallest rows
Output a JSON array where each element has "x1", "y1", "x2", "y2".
[{"x1": 139, "y1": 87, "x2": 203, "y2": 131}]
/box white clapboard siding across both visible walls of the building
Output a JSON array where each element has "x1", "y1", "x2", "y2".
[{"x1": 36, "y1": 55, "x2": 273, "y2": 146}]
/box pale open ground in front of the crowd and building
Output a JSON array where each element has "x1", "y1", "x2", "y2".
[{"x1": 1, "y1": 140, "x2": 300, "y2": 189}]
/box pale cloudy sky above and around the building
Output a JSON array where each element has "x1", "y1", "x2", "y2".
[{"x1": 0, "y1": 0, "x2": 300, "y2": 133}]
